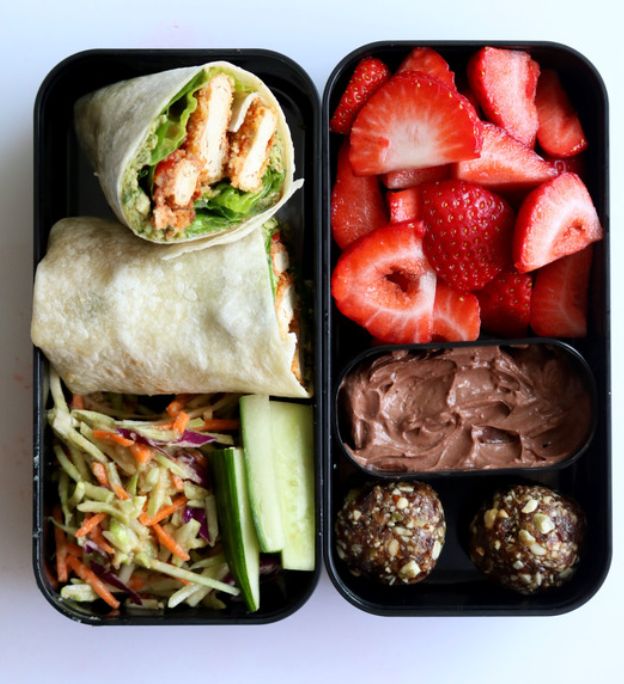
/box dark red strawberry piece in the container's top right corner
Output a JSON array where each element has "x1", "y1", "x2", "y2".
[{"x1": 535, "y1": 69, "x2": 587, "y2": 157}]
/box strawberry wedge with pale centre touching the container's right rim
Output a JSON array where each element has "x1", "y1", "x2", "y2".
[{"x1": 513, "y1": 173, "x2": 603, "y2": 273}]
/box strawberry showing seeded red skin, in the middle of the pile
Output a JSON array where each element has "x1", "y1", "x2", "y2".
[{"x1": 421, "y1": 180, "x2": 514, "y2": 291}]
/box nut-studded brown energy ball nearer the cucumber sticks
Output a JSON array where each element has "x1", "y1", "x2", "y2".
[{"x1": 336, "y1": 482, "x2": 446, "y2": 585}]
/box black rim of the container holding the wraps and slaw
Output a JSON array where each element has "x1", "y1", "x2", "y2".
[{"x1": 31, "y1": 48, "x2": 325, "y2": 627}]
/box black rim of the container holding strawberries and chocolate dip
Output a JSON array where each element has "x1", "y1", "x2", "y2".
[{"x1": 321, "y1": 38, "x2": 613, "y2": 617}]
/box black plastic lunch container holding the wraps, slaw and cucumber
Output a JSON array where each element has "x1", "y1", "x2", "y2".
[{"x1": 33, "y1": 50, "x2": 323, "y2": 625}]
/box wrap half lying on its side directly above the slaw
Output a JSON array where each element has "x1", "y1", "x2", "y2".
[{"x1": 31, "y1": 217, "x2": 309, "y2": 397}]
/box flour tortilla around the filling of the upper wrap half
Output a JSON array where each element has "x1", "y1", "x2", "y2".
[{"x1": 74, "y1": 62, "x2": 303, "y2": 249}]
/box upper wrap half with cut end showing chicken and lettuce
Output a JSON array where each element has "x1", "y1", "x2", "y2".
[{"x1": 74, "y1": 62, "x2": 302, "y2": 246}]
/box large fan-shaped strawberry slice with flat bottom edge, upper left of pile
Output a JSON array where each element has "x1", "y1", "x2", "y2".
[{"x1": 350, "y1": 71, "x2": 481, "y2": 175}]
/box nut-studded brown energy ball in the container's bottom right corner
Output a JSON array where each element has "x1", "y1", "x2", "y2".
[{"x1": 470, "y1": 485, "x2": 585, "y2": 594}]
